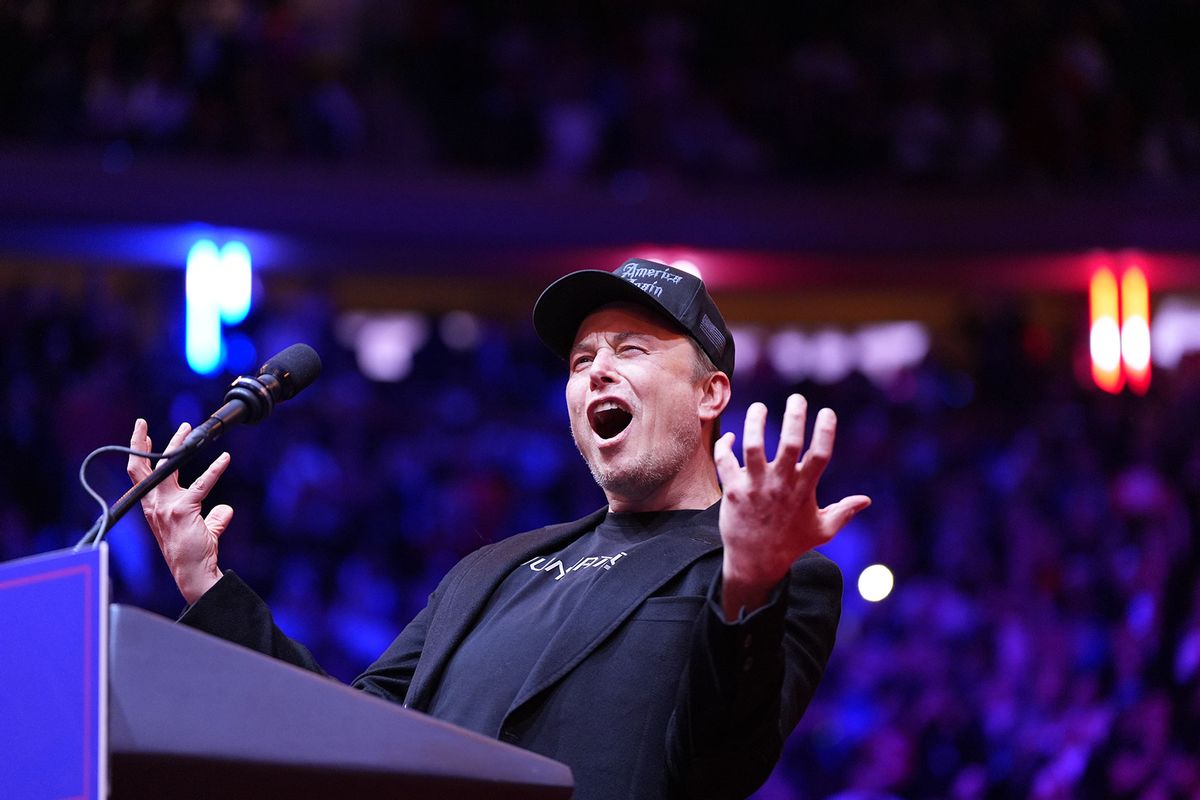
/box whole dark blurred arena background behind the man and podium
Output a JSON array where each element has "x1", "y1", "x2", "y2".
[{"x1": 0, "y1": 0, "x2": 1200, "y2": 800}]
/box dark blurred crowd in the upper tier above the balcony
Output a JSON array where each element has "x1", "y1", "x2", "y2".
[{"x1": 0, "y1": 0, "x2": 1200, "y2": 184}]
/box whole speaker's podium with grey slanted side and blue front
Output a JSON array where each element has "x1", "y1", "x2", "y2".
[{"x1": 0, "y1": 546, "x2": 574, "y2": 800}]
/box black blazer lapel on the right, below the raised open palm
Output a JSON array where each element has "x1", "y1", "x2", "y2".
[{"x1": 509, "y1": 505, "x2": 721, "y2": 714}]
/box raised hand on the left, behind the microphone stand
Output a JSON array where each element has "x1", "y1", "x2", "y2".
[{"x1": 127, "y1": 419, "x2": 233, "y2": 604}]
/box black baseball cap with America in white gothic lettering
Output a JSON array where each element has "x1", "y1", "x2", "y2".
[{"x1": 533, "y1": 258, "x2": 733, "y2": 379}]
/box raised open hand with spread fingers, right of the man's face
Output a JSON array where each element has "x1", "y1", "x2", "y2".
[{"x1": 713, "y1": 395, "x2": 871, "y2": 620}]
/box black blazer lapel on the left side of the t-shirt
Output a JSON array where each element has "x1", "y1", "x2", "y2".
[{"x1": 408, "y1": 507, "x2": 608, "y2": 709}]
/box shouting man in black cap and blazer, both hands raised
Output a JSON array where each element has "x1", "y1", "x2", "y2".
[{"x1": 130, "y1": 259, "x2": 870, "y2": 800}]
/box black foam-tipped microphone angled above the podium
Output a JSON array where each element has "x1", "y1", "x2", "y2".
[{"x1": 180, "y1": 343, "x2": 320, "y2": 452}]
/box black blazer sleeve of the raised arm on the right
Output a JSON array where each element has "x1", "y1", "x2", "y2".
[{"x1": 667, "y1": 553, "x2": 842, "y2": 799}]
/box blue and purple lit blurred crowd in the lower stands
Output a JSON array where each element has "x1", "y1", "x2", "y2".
[{"x1": 0, "y1": 273, "x2": 1200, "y2": 800}]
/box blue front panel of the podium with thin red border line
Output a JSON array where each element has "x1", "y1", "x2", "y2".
[{"x1": 0, "y1": 545, "x2": 108, "y2": 800}]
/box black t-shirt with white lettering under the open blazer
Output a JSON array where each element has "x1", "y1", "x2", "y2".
[{"x1": 430, "y1": 511, "x2": 700, "y2": 736}]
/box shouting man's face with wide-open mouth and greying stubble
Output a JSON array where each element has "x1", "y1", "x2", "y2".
[{"x1": 566, "y1": 303, "x2": 712, "y2": 503}]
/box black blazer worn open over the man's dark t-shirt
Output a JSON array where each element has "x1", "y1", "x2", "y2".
[{"x1": 180, "y1": 504, "x2": 841, "y2": 800}]
